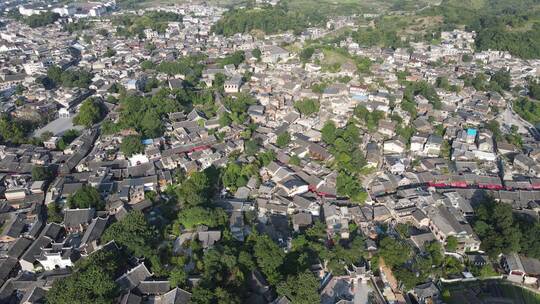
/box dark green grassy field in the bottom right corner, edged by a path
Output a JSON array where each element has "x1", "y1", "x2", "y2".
[{"x1": 443, "y1": 280, "x2": 540, "y2": 304}]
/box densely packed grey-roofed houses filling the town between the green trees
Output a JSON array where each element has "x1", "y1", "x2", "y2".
[{"x1": 0, "y1": 0, "x2": 540, "y2": 304}]
